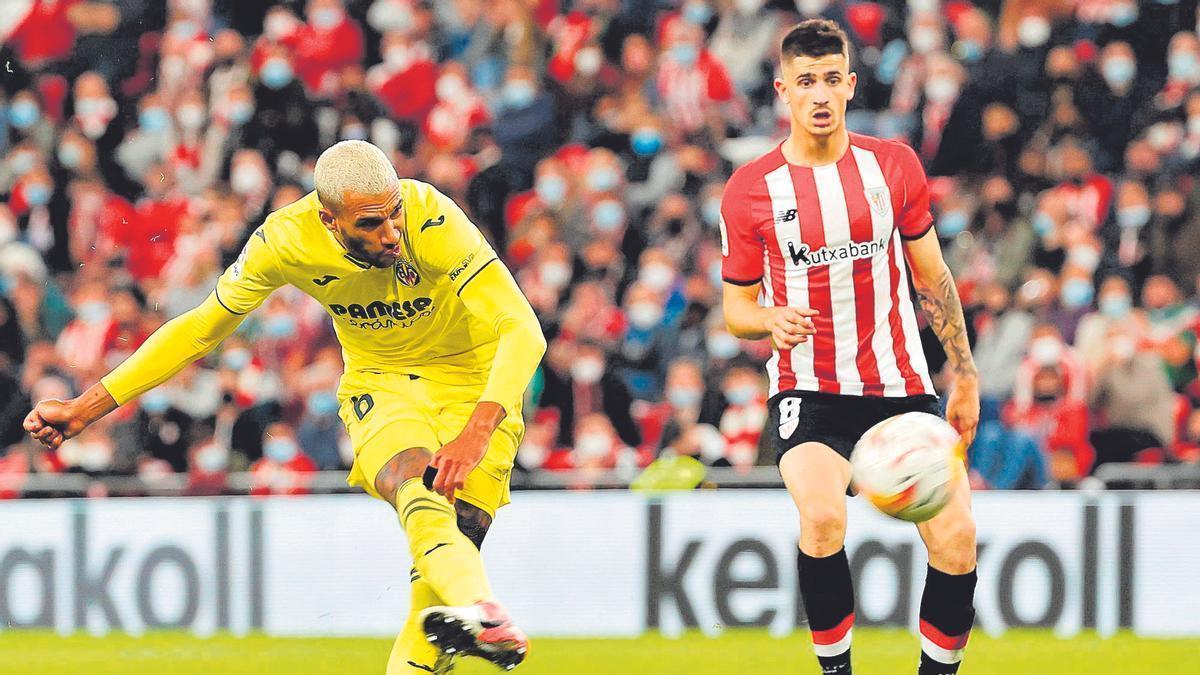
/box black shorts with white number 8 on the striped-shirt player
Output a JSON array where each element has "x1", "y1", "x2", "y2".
[{"x1": 762, "y1": 389, "x2": 942, "y2": 465}]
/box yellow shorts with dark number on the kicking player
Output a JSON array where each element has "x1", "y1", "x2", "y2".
[{"x1": 337, "y1": 371, "x2": 524, "y2": 516}]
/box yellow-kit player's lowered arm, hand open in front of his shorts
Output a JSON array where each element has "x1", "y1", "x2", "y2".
[{"x1": 430, "y1": 259, "x2": 546, "y2": 501}]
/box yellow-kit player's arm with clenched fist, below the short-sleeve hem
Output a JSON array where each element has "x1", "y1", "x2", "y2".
[{"x1": 24, "y1": 294, "x2": 244, "y2": 449}]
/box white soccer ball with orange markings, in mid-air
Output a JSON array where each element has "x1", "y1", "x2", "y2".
[{"x1": 850, "y1": 412, "x2": 962, "y2": 522}]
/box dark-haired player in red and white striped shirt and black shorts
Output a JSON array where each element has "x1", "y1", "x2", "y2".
[{"x1": 720, "y1": 19, "x2": 979, "y2": 675}]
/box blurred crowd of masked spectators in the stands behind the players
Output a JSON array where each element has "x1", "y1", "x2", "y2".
[{"x1": 7, "y1": 0, "x2": 1200, "y2": 494}]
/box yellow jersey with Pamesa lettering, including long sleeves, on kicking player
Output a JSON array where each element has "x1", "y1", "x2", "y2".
[{"x1": 102, "y1": 179, "x2": 545, "y2": 410}]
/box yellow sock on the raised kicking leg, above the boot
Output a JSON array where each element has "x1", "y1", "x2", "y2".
[{"x1": 396, "y1": 478, "x2": 492, "y2": 607}]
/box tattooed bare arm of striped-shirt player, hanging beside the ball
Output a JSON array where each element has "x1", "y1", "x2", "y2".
[{"x1": 905, "y1": 228, "x2": 979, "y2": 446}]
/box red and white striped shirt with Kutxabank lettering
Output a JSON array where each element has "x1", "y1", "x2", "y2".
[{"x1": 720, "y1": 133, "x2": 935, "y2": 396}]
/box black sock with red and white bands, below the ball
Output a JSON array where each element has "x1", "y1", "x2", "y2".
[{"x1": 917, "y1": 567, "x2": 976, "y2": 675}]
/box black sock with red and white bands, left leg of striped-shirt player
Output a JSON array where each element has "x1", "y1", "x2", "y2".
[{"x1": 797, "y1": 549, "x2": 854, "y2": 675}]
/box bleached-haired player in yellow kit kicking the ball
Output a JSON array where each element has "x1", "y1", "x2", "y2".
[{"x1": 25, "y1": 141, "x2": 546, "y2": 675}]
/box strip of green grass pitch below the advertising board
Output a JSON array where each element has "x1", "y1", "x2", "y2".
[{"x1": 0, "y1": 629, "x2": 1200, "y2": 675}]
